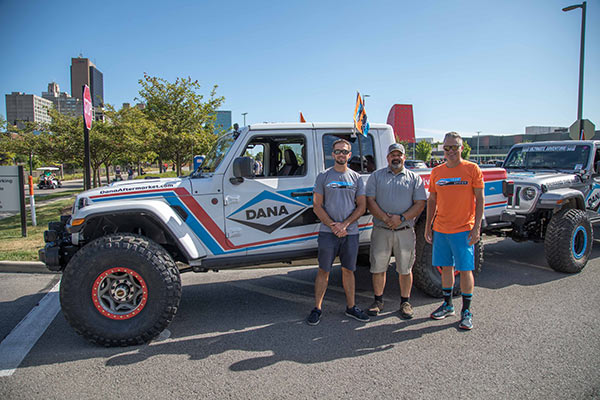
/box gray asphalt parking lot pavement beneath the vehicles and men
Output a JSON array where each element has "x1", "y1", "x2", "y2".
[{"x1": 0, "y1": 240, "x2": 600, "y2": 399}]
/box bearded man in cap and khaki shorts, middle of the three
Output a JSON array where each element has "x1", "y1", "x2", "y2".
[{"x1": 366, "y1": 143, "x2": 427, "y2": 319}]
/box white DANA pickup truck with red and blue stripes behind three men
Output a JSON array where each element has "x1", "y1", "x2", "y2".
[{"x1": 40, "y1": 123, "x2": 507, "y2": 346}]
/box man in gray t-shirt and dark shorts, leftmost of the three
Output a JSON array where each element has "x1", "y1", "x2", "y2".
[{"x1": 306, "y1": 139, "x2": 369, "y2": 325}]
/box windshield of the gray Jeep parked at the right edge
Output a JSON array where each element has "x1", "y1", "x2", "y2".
[{"x1": 504, "y1": 144, "x2": 590, "y2": 171}]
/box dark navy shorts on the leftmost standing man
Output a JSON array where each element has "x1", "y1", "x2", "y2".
[{"x1": 317, "y1": 232, "x2": 359, "y2": 272}]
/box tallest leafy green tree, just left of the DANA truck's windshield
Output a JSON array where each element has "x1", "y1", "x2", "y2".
[{"x1": 139, "y1": 74, "x2": 224, "y2": 175}]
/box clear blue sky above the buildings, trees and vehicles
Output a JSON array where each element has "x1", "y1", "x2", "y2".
[{"x1": 0, "y1": 0, "x2": 600, "y2": 138}]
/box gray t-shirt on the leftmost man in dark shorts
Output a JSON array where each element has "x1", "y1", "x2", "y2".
[{"x1": 314, "y1": 167, "x2": 365, "y2": 235}]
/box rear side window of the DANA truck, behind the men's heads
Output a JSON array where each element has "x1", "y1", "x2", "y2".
[{"x1": 323, "y1": 133, "x2": 377, "y2": 174}]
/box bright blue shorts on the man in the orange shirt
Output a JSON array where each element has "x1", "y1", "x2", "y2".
[{"x1": 432, "y1": 231, "x2": 475, "y2": 271}]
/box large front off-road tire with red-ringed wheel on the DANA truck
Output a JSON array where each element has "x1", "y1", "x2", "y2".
[{"x1": 60, "y1": 234, "x2": 181, "y2": 347}]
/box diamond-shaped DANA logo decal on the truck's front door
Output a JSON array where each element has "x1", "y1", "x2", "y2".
[{"x1": 227, "y1": 190, "x2": 306, "y2": 233}]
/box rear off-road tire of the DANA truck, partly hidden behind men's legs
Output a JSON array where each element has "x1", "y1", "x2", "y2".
[{"x1": 413, "y1": 221, "x2": 483, "y2": 297}]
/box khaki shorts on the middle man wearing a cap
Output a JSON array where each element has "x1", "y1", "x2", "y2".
[{"x1": 370, "y1": 226, "x2": 416, "y2": 275}]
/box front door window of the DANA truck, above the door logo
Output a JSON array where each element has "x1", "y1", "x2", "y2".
[{"x1": 242, "y1": 135, "x2": 306, "y2": 178}]
